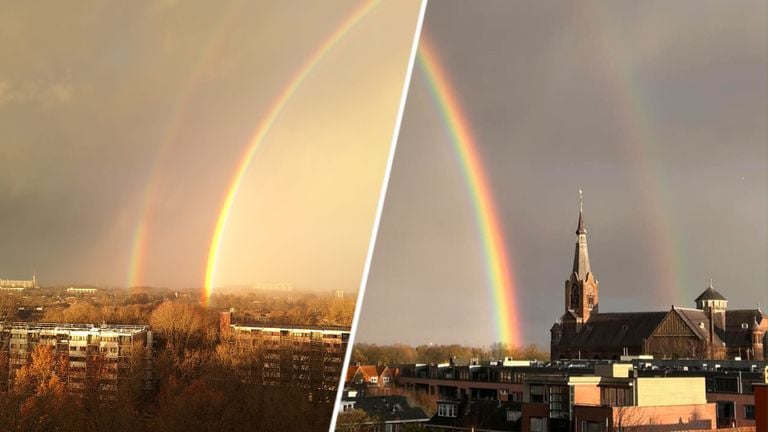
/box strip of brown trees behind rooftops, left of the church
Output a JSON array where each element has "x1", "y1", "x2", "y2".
[{"x1": 352, "y1": 343, "x2": 549, "y2": 365}]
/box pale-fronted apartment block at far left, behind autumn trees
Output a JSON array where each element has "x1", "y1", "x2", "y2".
[{"x1": 0, "y1": 322, "x2": 152, "y2": 396}]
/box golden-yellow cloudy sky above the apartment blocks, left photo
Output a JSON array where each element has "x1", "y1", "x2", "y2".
[{"x1": 0, "y1": 0, "x2": 419, "y2": 290}]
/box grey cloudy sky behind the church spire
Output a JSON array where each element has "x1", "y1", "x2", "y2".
[{"x1": 357, "y1": 1, "x2": 768, "y2": 345}]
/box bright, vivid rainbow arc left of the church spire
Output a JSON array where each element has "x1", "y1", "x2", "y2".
[{"x1": 417, "y1": 35, "x2": 522, "y2": 347}]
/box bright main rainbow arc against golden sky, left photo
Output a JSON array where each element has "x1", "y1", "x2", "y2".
[{"x1": 202, "y1": 0, "x2": 379, "y2": 303}]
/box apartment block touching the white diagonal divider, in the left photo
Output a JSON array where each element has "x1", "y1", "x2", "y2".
[{"x1": 220, "y1": 312, "x2": 350, "y2": 398}]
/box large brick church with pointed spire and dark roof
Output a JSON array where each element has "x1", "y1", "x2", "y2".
[{"x1": 550, "y1": 199, "x2": 768, "y2": 360}]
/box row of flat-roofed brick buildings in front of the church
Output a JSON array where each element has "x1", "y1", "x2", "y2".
[{"x1": 342, "y1": 358, "x2": 768, "y2": 432}]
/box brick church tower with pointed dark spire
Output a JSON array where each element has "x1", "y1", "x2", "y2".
[{"x1": 565, "y1": 190, "x2": 598, "y2": 328}]
